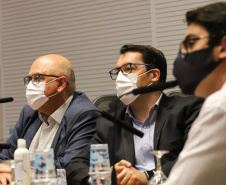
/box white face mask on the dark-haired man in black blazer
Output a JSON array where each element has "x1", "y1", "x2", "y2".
[{"x1": 115, "y1": 70, "x2": 152, "y2": 105}]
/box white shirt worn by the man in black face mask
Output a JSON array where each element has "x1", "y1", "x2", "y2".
[{"x1": 164, "y1": 82, "x2": 226, "y2": 185}]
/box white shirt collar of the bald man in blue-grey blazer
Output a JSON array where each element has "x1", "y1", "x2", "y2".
[{"x1": 39, "y1": 95, "x2": 73, "y2": 124}]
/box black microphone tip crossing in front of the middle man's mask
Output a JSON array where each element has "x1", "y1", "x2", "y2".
[{"x1": 132, "y1": 80, "x2": 178, "y2": 95}]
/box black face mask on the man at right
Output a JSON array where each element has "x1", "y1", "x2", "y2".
[{"x1": 173, "y1": 47, "x2": 220, "y2": 95}]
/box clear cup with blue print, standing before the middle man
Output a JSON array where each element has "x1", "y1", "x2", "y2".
[{"x1": 89, "y1": 144, "x2": 111, "y2": 185}]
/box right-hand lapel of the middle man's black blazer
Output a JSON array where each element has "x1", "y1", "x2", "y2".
[{"x1": 154, "y1": 94, "x2": 172, "y2": 150}]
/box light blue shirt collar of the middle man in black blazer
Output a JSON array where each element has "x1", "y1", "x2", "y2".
[{"x1": 125, "y1": 93, "x2": 163, "y2": 127}]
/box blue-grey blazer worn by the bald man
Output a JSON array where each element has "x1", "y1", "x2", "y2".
[{"x1": 0, "y1": 91, "x2": 99, "y2": 168}]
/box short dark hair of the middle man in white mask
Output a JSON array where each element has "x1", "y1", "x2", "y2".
[{"x1": 120, "y1": 44, "x2": 167, "y2": 82}]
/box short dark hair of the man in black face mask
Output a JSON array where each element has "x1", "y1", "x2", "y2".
[{"x1": 186, "y1": 2, "x2": 226, "y2": 46}]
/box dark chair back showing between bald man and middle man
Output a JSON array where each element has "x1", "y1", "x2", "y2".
[{"x1": 93, "y1": 94, "x2": 125, "y2": 113}]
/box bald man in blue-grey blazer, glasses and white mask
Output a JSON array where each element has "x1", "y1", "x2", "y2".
[{"x1": 0, "y1": 54, "x2": 99, "y2": 184}]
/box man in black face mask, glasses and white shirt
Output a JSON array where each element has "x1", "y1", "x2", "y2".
[{"x1": 164, "y1": 2, "x2": 226, "y2": 185}]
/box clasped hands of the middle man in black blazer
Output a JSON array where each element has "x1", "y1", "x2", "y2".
[{"x1": 115, "y1": 160, "x2": 148, "y2": 185}]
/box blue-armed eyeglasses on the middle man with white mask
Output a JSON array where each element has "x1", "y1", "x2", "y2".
[{"x1": 109, "y1": 63, "x2": 149, "y2": 80}]
